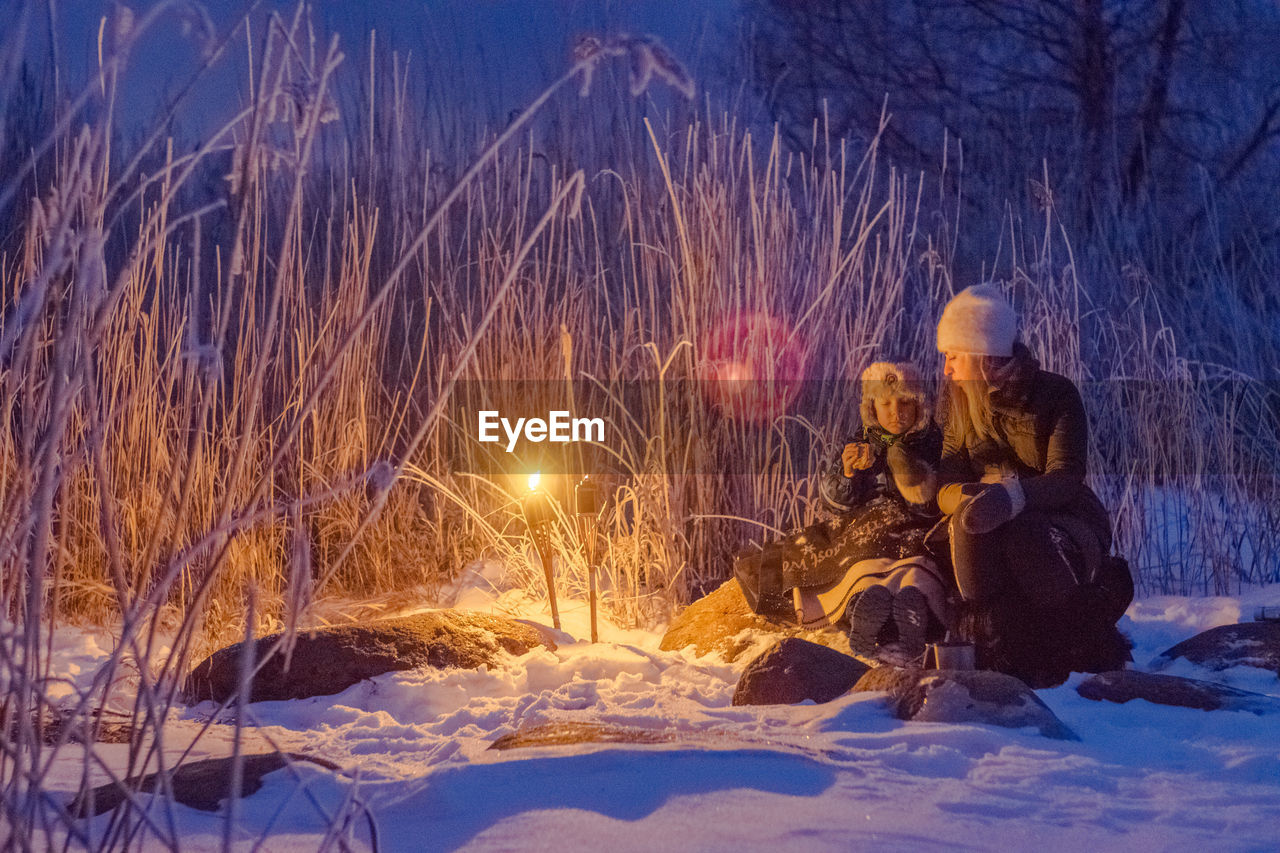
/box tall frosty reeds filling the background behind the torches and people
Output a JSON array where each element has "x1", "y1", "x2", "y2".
[{"x1": 0, "y1": 3, "x2": 1280, "y2": 848}]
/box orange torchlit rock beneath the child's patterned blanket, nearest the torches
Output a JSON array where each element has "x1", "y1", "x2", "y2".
[{"x1": 659, "y1": 578, "x2": 850, "y2": 661}]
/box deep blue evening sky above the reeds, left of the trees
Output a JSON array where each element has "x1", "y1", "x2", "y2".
[{"x1": 45, "y1": 0, "x2": 736, "y2": 133}]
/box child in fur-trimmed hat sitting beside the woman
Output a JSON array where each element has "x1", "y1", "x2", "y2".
[{"x1": 796, "y1": 361, "x2": 947, "y2": 661}]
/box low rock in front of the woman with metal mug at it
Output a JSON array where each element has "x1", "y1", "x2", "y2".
[{"x1": 854, "y1": 666, "x2": 1080, "y2": 740}]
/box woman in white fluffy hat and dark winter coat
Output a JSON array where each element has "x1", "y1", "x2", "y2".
[{"x1": 937, "y1": 284, "x2": 1133, "y2": 686}]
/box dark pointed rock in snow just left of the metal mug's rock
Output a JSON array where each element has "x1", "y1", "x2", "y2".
[{"x1": 733, "y1": 637, "x2": 868, "y2": 704}]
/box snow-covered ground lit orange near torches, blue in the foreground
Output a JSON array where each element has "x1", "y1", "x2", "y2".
[{"x1": 35, "y1": 560, "x2": 1280, "y2": 852}]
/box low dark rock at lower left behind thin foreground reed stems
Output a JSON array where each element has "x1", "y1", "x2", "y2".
[{"x1": 69, "y1": 752, "x2": 338, "y2": 817}]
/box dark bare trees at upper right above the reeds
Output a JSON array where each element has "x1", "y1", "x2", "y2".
[{"x1": 748, "y1": 0, "x2": 1280, "y2": 235}]
